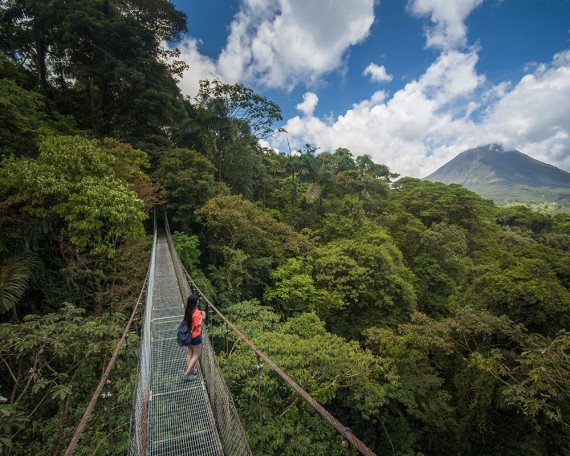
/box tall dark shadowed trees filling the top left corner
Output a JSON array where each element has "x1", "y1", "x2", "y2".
[{"x1": 0, "y1": 0, "x2": 186, "y2": 144}]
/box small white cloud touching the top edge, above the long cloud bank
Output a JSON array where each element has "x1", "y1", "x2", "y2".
[{"x1": 408, "y1": 0, "x2": 483, "y2": 50}]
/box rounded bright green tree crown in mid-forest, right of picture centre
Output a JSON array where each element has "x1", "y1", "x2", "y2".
[{"x1": 265, "y1": 225, "x2": 416, "y2": 338}]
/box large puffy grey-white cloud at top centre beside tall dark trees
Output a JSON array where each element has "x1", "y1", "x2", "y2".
[{"x1": 175, "y1": 0, "x2": 375, "y2": 94}]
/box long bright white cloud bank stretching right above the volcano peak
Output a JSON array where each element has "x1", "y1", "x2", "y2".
[{"x1": 274, "y1": 50, "x2": 570, "y2": 177}]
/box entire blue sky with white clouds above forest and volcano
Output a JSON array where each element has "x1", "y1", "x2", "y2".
[{"x1": 168, "y1": 0, "x2": 570, "y2": 178}]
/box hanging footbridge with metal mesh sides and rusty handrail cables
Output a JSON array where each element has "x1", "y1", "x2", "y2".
[{"x1": 65, "y1": 214, "x2": 375, "y2": 456}]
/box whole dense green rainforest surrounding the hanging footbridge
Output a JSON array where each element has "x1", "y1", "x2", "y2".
[{"x1": 0, "y1": 0, "x2": 570, "y2": 456}]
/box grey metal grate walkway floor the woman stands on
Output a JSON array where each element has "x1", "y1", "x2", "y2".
[{"x1": 148, "y1": 235, "x2": 223, "y2": 456}]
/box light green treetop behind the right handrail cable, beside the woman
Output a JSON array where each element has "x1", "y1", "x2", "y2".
[{"x1": 214, "y1": 302, "x2": 384, "y2": 455}]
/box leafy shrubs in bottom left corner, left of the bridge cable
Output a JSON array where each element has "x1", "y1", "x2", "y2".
[{"x1": 0, "y1": 304, "x2": 135, "y2": 455}]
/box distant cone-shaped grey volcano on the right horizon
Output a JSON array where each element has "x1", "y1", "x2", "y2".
[{"x1": 424, "y1": 144, "x2": 570, "y2": 211}]
